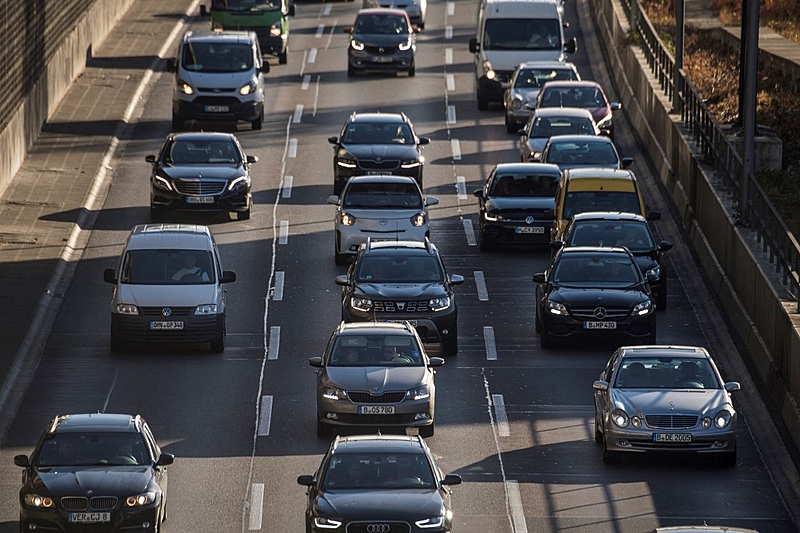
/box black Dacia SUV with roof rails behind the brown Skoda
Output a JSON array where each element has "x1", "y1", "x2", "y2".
[{"x1": 336, "y1": 238, "x2": 464, "y2": 355}]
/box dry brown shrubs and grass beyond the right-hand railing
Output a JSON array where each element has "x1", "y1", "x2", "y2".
[{"x1": 643, "y1": 0, "x2": 800, "y2": 236}]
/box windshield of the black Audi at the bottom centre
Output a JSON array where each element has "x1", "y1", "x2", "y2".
[{"x1": 322, "y1": 453, "x2": 435, "y2": 490}]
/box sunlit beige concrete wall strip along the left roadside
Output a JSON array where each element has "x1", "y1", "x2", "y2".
[{"x1": 0, "y1": 0, "x2": 135, "y2": 194}]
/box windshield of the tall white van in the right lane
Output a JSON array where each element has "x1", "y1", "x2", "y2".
[{"x1": 481, "y1": 18, "x2": 562, "y2": 51}]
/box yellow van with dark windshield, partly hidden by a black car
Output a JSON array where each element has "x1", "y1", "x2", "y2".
[{"x1": 550, "y1": 168, "x2": 661, "y2": 240}]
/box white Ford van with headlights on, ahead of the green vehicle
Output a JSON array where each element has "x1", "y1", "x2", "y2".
[{"x1": 167, "y1": 31, "x2": 269, "y2": 131}]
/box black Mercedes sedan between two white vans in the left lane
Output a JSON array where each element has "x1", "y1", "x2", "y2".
[{"x1": 145, "y1": 132, "x2": 253, "y2": 220}]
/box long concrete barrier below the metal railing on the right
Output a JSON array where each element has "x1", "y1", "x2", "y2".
[{"x1": 587, "y1": 0, "x2": 800, "y2": 448}]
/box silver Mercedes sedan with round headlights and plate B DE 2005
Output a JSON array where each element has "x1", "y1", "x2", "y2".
[{"x1": 593, "y1": 345, "x2": 741, "y2": 466}]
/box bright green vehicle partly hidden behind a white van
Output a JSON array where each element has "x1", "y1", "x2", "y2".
[{"x1": 200, "y1": 0, "x2": 294, "y2": 65}]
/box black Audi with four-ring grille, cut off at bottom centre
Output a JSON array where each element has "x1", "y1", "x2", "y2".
[{"x1": 297, "y1": 435, "x2": 461, "y2": 533}]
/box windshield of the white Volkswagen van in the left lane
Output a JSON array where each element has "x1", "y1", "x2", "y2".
[{"x1": 120, "y1": 250, "x2": 216, "y2": 285}]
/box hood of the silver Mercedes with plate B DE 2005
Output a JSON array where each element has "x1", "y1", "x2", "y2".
[{"x1": 611, "y1": 389, "x2": 730, "y2": 417}]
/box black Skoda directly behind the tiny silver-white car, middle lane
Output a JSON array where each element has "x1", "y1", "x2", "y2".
[{"x1": 328, "y1": 112, "x2": 431, "y2": 196}]
